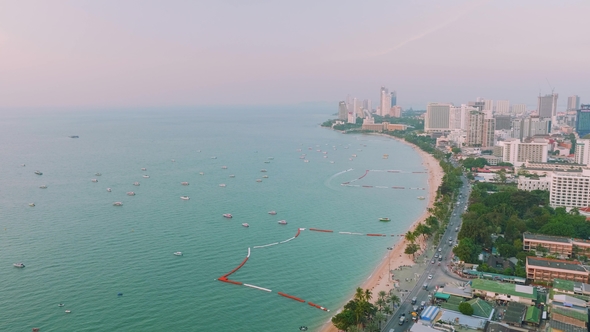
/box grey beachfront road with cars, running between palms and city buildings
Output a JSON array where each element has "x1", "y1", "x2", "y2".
[{"x1": 382, "y1": 176, "x2": 471, "y2": 332}]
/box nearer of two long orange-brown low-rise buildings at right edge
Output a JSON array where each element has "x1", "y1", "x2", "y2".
[{"x1": 526, "y1": 256, "x2": 590, "y2": 283}]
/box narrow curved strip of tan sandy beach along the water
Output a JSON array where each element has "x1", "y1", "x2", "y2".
[{"x1": 321, "y1": 135, "x2": 444, "y2": 332}]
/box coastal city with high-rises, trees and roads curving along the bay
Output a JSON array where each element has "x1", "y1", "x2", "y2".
[{"x1": 322, "y1": 87, "x2": 590, "y2": 332}]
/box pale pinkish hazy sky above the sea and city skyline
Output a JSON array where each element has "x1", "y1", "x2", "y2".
[{"x1": 0, "y1": 0, "x2": 590, "y2": 109}]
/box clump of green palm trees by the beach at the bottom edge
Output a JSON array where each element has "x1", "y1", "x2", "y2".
[{"x1": 332, "y1": 287, "x2": 400, "y2": 332}]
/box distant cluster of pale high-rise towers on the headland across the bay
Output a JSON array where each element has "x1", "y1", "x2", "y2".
[{"x1": 338, "y1": 86, "x2": 402, "y2": 123}]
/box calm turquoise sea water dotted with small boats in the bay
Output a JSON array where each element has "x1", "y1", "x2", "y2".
[{"x1": 0, "y1": 105, "x2": 427, "y2": 332}]
